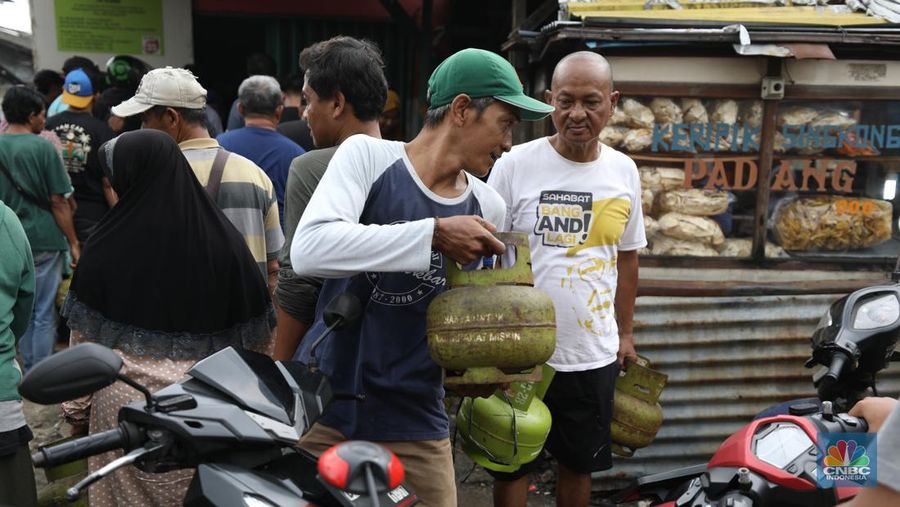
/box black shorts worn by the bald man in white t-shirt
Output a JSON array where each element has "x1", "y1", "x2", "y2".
[{"x1": 488, "y1": 361, "x2": 619, "y2": 481}]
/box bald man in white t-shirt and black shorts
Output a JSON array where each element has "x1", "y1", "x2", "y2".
[{"x1": 488, "y1": 51, "x2": 647, "y2": 506}]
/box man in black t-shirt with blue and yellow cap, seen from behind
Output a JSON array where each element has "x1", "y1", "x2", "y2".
[{"x1": 47, "y1": 69, "x2": 117, "y2": 243}]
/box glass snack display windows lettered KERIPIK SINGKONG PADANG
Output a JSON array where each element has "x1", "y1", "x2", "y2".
[{"x1": 600, "y1": 96, "x2": 900, "y2": 259}]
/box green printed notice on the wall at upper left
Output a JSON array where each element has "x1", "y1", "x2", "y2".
[{"x1": 55, "y1": 0, "x2": 165, "y2": 55}]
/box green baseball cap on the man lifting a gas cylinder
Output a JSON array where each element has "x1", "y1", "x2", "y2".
[{"x1": 428, "y1": 48, "x2": 553, "y2": 121}]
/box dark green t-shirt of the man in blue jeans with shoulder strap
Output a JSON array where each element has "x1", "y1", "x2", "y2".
[{"x1": 0, "y1": 134, "x2": 73, "y2": 252}]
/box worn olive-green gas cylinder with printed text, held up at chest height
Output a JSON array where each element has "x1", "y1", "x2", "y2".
[{"x1": 427, "y1": 233, "x2": 556, "y2": 385}]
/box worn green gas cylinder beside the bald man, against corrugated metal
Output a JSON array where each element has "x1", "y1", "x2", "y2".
[{"x1": 611, "y1": 356, "x2": 669, "y2": 457}]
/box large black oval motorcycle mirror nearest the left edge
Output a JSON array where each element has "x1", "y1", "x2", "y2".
[{"x1": 19, "y1": 343, "x2": 122, "y2": 405}]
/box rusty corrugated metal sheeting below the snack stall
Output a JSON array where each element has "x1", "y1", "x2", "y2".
[{"x1": 595, "y1": 295, "x2": 900, "y2": 489}]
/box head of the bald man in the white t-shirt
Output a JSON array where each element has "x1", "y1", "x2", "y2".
[{"x1": 546, "y1": 60, "x2": 619, "y2": 144}]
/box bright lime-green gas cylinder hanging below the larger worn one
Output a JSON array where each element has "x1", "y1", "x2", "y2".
[{"x1": 456, "y1": 365, "x2": 554, "y2": 473}]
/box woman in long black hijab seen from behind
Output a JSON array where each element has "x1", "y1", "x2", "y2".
[{"x1": 63, "y1": 130, "x2": 275, "y2": 507}]
